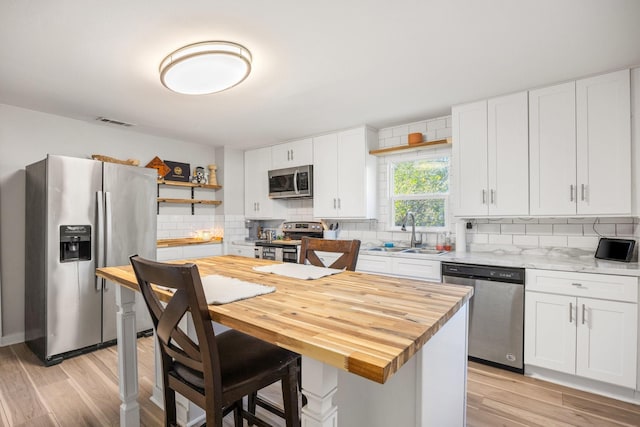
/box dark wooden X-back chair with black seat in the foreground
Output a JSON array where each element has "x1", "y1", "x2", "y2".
[{"x1": 131, "y1": 255, "x2": 300, "y2": 427}]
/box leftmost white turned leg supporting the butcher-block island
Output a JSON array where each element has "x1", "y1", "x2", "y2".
[{"x1": 115, "y1": 285, "x2": 140, "y2": 427}]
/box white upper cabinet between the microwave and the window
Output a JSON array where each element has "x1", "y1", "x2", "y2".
[{"x1": 313, "y1": 127, "x2": 377, "y2": 218}]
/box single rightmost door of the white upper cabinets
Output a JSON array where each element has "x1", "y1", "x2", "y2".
[{"x1": 576, "y1": 70, "x2": 631, "y2": 215}]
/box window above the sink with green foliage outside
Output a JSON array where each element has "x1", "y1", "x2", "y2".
[{"x1": 389, "y1": 155, "x2": 449, "y2": 230}]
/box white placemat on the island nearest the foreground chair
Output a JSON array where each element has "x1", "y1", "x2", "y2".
[{"x1": 201, "y1": 274, "x2": 276, "y2": 305}]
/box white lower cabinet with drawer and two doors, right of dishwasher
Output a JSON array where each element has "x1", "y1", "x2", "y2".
[{"x1": 524, "y1": 270, "x2": 638, "y2": 388}]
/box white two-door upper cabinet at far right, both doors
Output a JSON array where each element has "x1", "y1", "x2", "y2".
[{"x1": 529, "y1": 70, "x2": 631, "y2": 215}]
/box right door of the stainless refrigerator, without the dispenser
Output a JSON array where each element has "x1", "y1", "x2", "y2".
[{"x1": 103, "y1": 163, "x2": 157, "y2": 342}]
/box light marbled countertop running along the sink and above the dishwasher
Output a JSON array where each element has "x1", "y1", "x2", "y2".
[{"x1": 360, "y1": 246, "x2": 640, "y2": 277}]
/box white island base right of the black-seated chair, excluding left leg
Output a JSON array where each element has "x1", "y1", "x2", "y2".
[{"x1": 302, "y1": 304, "x2": 468, "y2": 427}]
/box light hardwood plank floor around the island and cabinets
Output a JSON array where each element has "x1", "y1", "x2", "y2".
[{"x1": 0, "y1": 338, "x2": 640, "y2": 427}]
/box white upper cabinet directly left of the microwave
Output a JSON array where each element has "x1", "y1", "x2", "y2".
[{"x1": 244, "y1": 147, "x2": 282, "y2": 219}]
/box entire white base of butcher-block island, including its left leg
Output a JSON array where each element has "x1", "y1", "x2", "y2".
[{"x1": 116, "y1": 286, "x2": 468, "y2": 427}]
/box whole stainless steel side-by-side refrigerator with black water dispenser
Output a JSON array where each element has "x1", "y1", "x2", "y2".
[{"x1": 25, "y1": 155, "x2": 157, "y2": 365}]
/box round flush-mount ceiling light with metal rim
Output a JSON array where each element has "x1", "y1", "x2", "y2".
[{"x1": 160, "y1": 41, "x2": 251, "y2": 95}]
